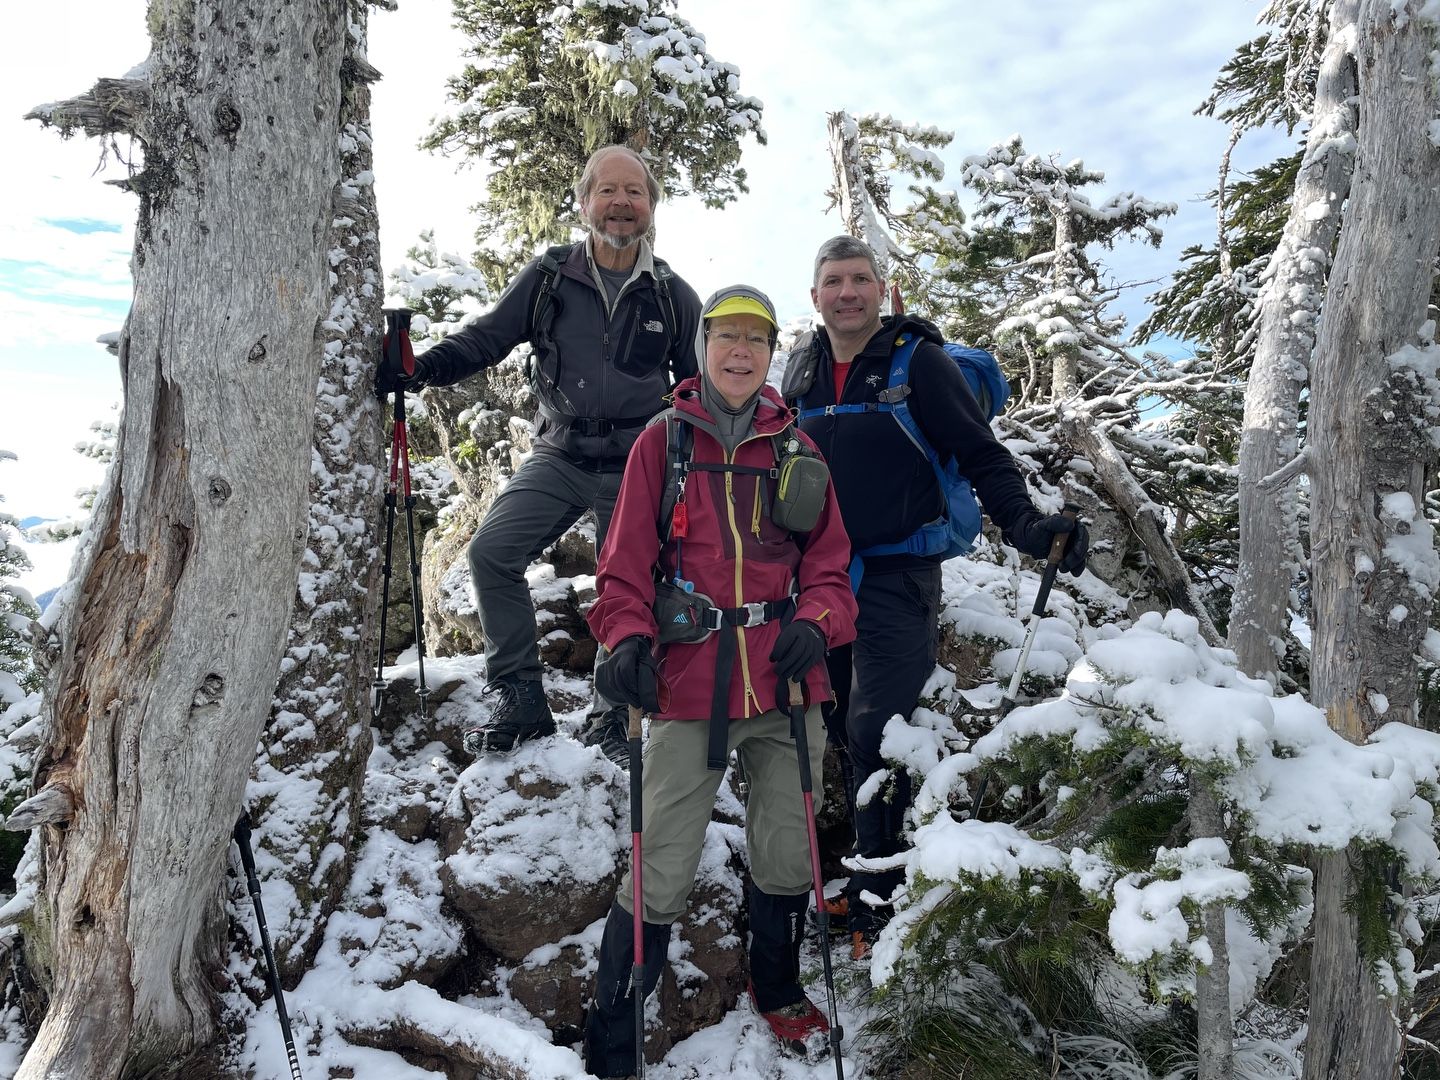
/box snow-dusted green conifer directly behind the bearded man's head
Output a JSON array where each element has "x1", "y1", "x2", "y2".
[{"x1": 423, "y1": 0, "x2": 765, "y2": 275}]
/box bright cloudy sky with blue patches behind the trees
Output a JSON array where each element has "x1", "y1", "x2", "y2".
[{"x1": 0, "y1": 0, "x2": 1286, "y2": 527}]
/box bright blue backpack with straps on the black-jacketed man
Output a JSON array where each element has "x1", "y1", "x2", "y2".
[{"x1": 796, "y1": 334, "x2": 1009, "y2": 561}]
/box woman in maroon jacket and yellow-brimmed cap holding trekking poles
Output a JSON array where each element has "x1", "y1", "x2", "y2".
[{"x1": 585, "y1": 287, "x2": 855, "y2": 1077}]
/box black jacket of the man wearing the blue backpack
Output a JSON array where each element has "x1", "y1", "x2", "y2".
[{"x1": 783, "y1": 315, "x2": 1040, "y2": 572}]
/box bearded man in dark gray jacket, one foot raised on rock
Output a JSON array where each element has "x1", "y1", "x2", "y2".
[{"x1": 376, "y1": 145, "x2": 700, "y2": 768}]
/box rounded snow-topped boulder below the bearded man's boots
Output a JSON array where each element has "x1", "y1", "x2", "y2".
[{"x1": 439, "y1": 736, "x2": 629, "y2": 962}]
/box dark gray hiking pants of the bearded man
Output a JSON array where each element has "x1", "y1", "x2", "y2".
[{"x1": 469, "y1": 454, "x2": 621, "y2": 680}]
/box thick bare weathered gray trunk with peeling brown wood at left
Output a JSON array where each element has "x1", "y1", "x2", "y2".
[{"x1": 19, "y1": 0, "x2": 346, "y2": 1080}]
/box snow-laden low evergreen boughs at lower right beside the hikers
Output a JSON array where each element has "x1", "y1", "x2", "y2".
[{"x1": 871, "y1": 611, "x2": 1440, "y2": 998}]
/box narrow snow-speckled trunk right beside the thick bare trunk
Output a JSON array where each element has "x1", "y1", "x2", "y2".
[{"x1": 245, "y1": 0, "x2": 383, "y2": 985}]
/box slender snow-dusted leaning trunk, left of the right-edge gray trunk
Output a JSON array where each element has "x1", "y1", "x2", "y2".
[{"x1": 1225, "y1": 0, "x2": 1359, "y2": 685}]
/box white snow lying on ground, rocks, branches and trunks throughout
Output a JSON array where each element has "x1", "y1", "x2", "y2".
[{"x1": 11, "y1": 0, "x2": 1440, "y2": 1080}]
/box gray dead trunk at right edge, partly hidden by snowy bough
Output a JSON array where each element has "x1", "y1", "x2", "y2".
[{"x1": 1305, "y1": 0, "x2": 1440, "y2": 1080}]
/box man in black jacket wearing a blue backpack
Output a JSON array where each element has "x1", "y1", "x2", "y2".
[{"x1": 782, "y1": 236, "x2": 1089, "y2": 959}]
